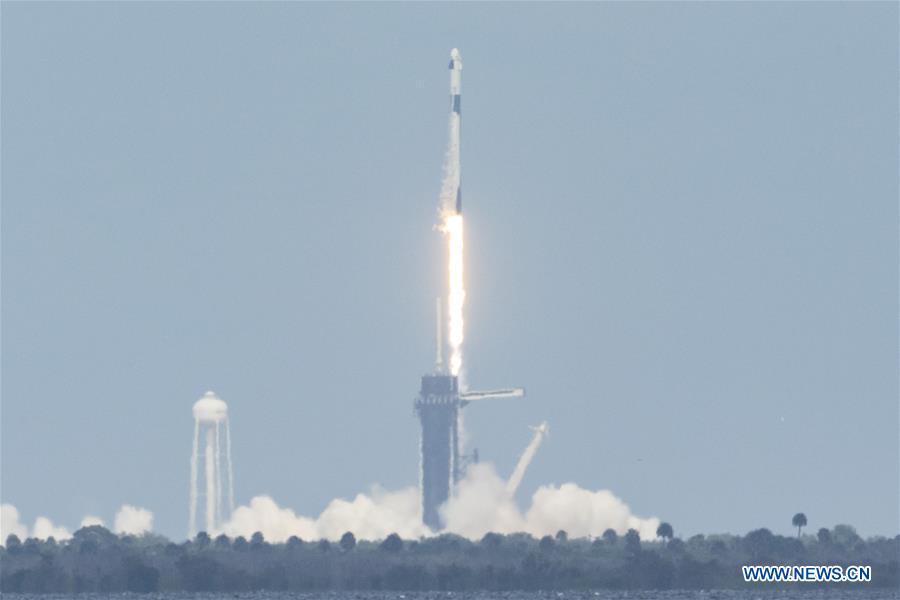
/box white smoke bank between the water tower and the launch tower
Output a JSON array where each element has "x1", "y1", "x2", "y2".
[{"x1": 222, "y1": 487, "x2": 429, "y2": 542}]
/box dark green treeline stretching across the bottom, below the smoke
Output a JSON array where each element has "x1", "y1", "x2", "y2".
[{"x1": 0, "y1": 520, "x2": 900, "y2": 593}]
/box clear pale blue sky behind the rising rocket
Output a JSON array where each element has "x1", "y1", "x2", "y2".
[{"x1": 0, "y1": 2, "x2": 900, "y2": 536}]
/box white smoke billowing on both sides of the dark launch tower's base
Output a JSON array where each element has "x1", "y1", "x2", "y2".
[{"x1": 215, "y1": 463, "x2": 659, "y2": 542}]
